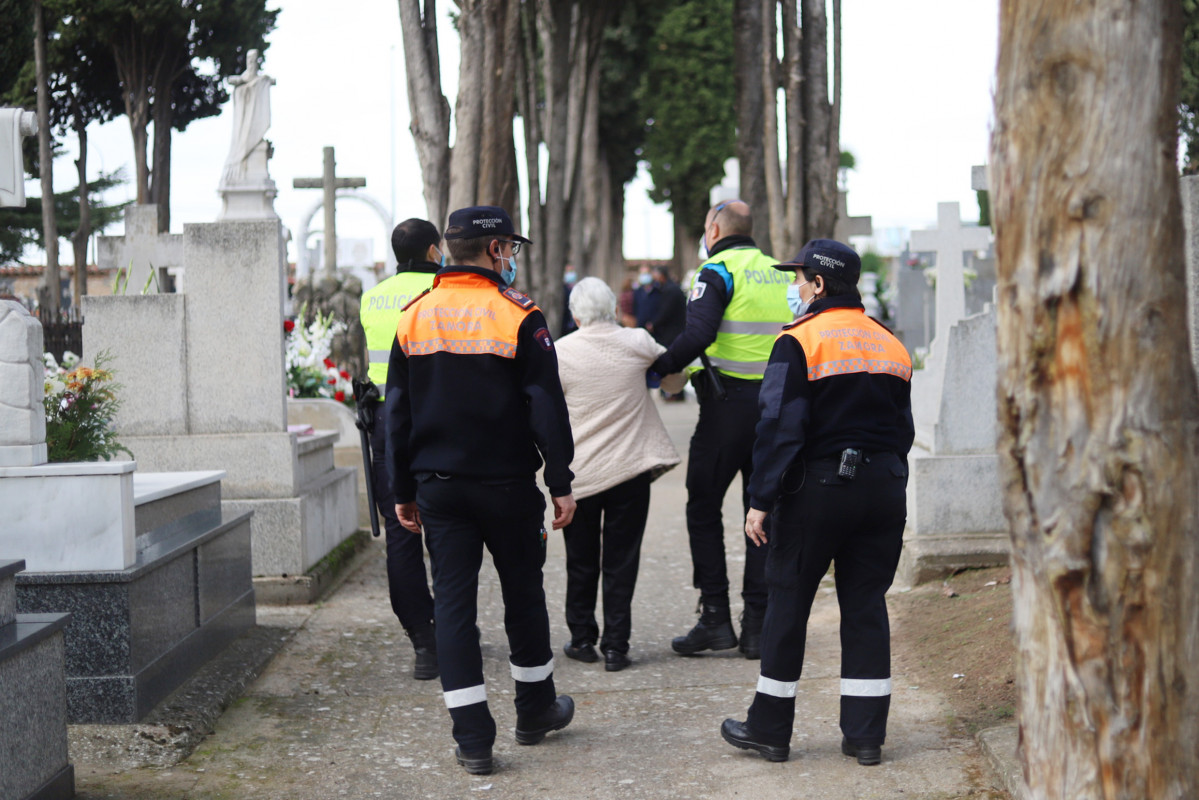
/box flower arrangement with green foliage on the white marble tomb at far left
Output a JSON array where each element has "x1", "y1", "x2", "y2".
[{"x1": 42, "y1": 351, "x2": 133, "y2": 463}]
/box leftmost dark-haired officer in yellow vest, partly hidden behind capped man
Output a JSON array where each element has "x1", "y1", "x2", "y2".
[{"x1": 359, "y1": 218, "x2": 445, "y2": 680}]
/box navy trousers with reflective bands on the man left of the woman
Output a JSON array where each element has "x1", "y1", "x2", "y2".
[{"x1": 416, "y1": 475, "x2": 558, "y2": 752}]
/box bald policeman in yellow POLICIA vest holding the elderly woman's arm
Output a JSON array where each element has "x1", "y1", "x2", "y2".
[{"x1": 652, "y1": 200, "x2": 791, "y2": 658}]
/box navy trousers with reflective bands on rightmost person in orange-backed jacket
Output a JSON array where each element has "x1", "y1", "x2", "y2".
[{"x1": 746, "y1": 453, "x2": 908, "y2": 746}]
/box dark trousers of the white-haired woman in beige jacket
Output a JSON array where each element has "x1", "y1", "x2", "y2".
[{"x1": 562, "y1": 473, "x2": 650, "y2": 652}]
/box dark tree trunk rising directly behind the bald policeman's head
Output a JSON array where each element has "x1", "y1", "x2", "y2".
[{"x1": 733, "y1": 0, "x2": 778, "y2": 252}]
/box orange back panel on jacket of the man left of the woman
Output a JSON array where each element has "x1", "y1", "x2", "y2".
[{"x1": 396, "y1": 272, "x2": 537, "y2": 359}]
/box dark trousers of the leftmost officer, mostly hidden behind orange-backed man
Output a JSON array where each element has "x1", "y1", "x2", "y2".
[{"x1": 370, "y1": 410, "x2": 433, "y2": 633}]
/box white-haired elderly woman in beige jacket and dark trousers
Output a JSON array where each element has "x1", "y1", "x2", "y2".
[{"x1": 556, "y1": 278, "x2": 683, "y2": 672}]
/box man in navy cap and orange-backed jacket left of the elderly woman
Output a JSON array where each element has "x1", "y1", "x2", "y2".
[{"x1": 386, "y1": 206, "x2": 574, "y2": 775}]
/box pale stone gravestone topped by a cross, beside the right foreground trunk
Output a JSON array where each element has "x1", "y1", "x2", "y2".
[{"x1": 899, "y1": 188, "x2": 1008, "y2": 584}]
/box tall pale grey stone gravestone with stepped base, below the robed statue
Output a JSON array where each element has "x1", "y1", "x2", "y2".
[{"x1": 84, "y1": 219, "x2": 357, "y2": 599}]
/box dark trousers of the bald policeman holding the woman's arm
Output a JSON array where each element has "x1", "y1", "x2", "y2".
[{"x1": 687, "y1": 374, "x2": 766, "y2": 613}]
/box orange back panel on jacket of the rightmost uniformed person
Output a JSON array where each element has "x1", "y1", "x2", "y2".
[{"x1": 779, "y1": 308, "x2": 911, "y2": 381}]
